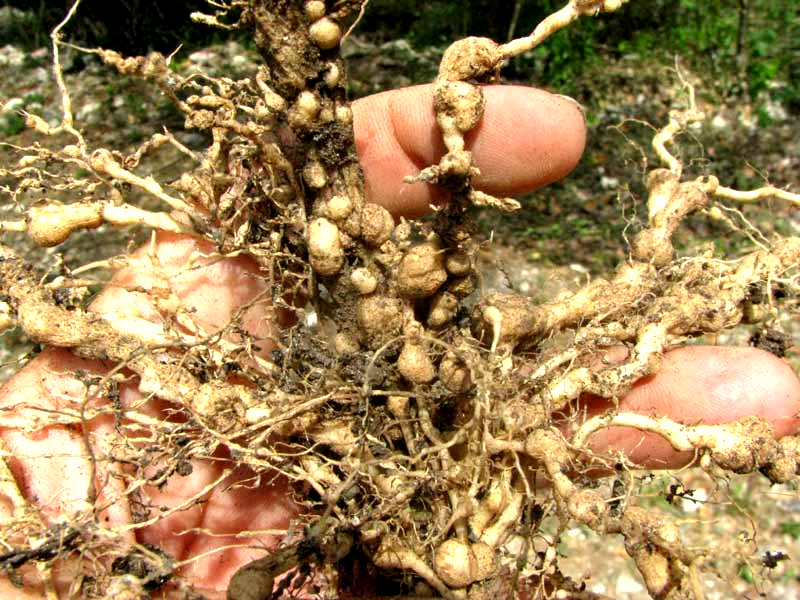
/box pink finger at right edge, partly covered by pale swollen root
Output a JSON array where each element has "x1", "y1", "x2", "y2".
[{"x1": 587, "y1": 346, "x2": 800, "y2": 468}]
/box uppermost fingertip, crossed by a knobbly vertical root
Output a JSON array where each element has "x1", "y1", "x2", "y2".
[{"x1": 353, "y1": 85, "x2": 586, "y2": 217}]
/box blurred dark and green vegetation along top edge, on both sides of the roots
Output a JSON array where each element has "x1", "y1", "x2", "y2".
[{"x1": 0, "y1": 0, "x2": 800, "y2": 113}]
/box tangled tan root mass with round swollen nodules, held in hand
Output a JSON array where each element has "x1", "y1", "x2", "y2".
[{"x1": 0, "y1": 0, "x2": 800, "y2": 600}]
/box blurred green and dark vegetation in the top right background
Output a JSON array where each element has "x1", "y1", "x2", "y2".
[{"x1": 361, "y1": 0, "x2": 800, "y2": 113}]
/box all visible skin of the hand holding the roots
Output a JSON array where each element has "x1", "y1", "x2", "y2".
[{"x1": 0, "y1": 86, "x2": 800, "y2": 598}]
